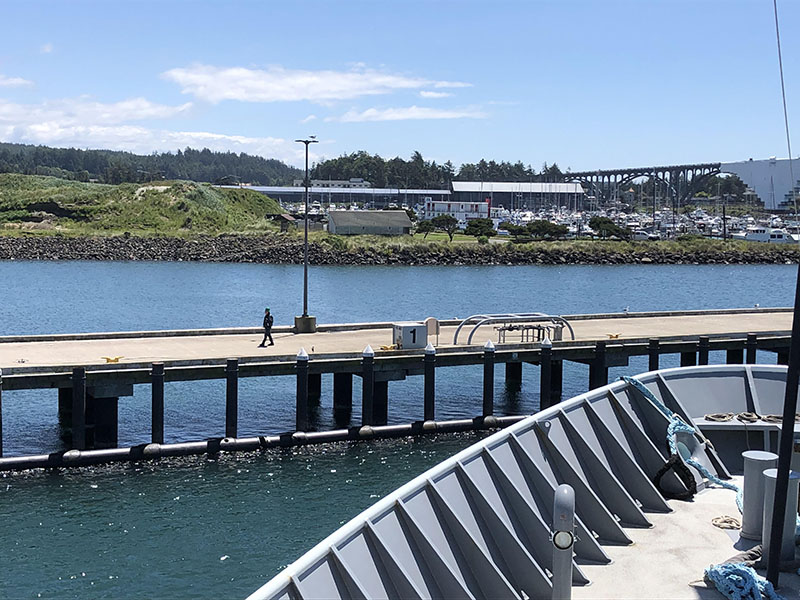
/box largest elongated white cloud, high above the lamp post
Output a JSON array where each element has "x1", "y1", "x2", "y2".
[{"x1": 162, "y1": 65, "x2": 471, "y2": 103}]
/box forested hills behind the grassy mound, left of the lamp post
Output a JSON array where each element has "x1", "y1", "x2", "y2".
[{"x1": 0, "y1": 142, "x2": 302, "y2": 185}]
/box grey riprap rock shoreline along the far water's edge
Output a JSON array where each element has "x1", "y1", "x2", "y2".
[{"x1": 0, "y1": 235, "x2": 800, "y2": 265}]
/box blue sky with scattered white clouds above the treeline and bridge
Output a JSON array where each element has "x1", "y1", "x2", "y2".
[{"x1": 0, "y1": 0, "x2": 800, "y2": 171}]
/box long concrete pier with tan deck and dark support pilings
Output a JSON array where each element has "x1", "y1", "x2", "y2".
[{"x1": 0, "y1": 309, "x2": 791, "y2": 456}]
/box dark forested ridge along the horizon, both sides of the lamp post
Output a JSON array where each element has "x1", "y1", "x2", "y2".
[{"x1": 0, "y1": 142, "x2": 746, "y2": 198}]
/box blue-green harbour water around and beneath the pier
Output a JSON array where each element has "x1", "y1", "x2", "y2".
[{"x1": 0, "y1": 262, "x2": 796, "y2": 598}]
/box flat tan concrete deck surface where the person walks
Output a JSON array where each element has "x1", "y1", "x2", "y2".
[{"x1": 0, "y1": 309, "x2": 792, "y2": 375}]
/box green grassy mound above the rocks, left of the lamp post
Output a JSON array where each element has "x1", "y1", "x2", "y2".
[{"x1": 0, "y1": 173, "x2": 281, "y2": 235}]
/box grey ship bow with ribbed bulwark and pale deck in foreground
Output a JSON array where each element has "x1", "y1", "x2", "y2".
[{"x1": 250, "y1": 365, "x2": 800, "y2": 600}]
